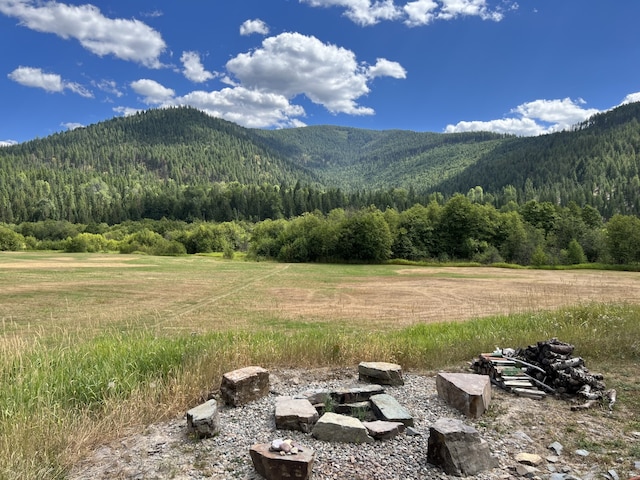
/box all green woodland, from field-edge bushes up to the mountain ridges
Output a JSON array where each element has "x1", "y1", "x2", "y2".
[{"x1": 0, "y1": 103, "x2": 640, "y2": 265}]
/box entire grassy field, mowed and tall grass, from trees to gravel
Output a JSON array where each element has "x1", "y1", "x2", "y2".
[{"x1": 0, "y1": 252, "x2": 640, "y2": 479}]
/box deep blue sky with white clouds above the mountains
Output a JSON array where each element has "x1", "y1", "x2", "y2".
[{"x1": 0, "y1": 0, "x2": 640, "y2": 145}]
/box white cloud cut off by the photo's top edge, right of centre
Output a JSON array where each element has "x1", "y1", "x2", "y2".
[{"x1": 300, "y1": 0, "x2": 518, "y2": 27}]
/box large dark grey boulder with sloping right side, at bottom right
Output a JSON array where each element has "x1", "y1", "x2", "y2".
[{"x1": 427, "y1": 418, "x2": 498, "y2": 476}]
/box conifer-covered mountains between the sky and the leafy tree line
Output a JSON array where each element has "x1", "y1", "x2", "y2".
[{"x1": 0, "y1": 103, "x2": 640, "y2": 224}]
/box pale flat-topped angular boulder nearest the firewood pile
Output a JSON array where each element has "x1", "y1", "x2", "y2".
[{"x1": 436, "y1": 372, "x2": 491, "y2": 418}]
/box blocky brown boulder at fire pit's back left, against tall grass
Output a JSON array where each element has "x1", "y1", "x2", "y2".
[{"x1": 220, "y1": 366, "x2": 269, "y2": 406}]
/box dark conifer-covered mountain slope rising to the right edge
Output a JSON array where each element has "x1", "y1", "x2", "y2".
[{"x1": 434, "y1": 103, "x2": 640, "y2": 217}]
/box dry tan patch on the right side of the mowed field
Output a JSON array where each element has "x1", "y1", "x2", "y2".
[{"x1": 264, "y1": 267, "x2": 640, "y2": 326}]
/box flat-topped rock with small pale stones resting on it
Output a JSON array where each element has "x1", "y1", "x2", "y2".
[{"x1": 249, "y1": 443, "x2": 315, "y2": 480}]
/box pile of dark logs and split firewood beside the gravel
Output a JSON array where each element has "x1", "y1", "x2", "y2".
[{"x1": 472, "y1": 338, "x2": 616, "y2": 410}]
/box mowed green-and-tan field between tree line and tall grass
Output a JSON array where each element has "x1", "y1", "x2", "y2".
[{"x1": 0, "y1": 252, "x2": 640, "y2": 340}]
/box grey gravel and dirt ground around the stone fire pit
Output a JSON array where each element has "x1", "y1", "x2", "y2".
[{"x1": 70, "y1": 369, "x2": 632, "y2": 480}]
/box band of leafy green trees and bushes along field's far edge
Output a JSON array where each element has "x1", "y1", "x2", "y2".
[{"x1": 5, "y1": 197, "x2": 640, "y2": 266}]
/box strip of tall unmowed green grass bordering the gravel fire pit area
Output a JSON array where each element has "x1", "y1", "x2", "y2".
[{"x1": 0, "y1": 304, "x2": 640, "y2": 479}]
